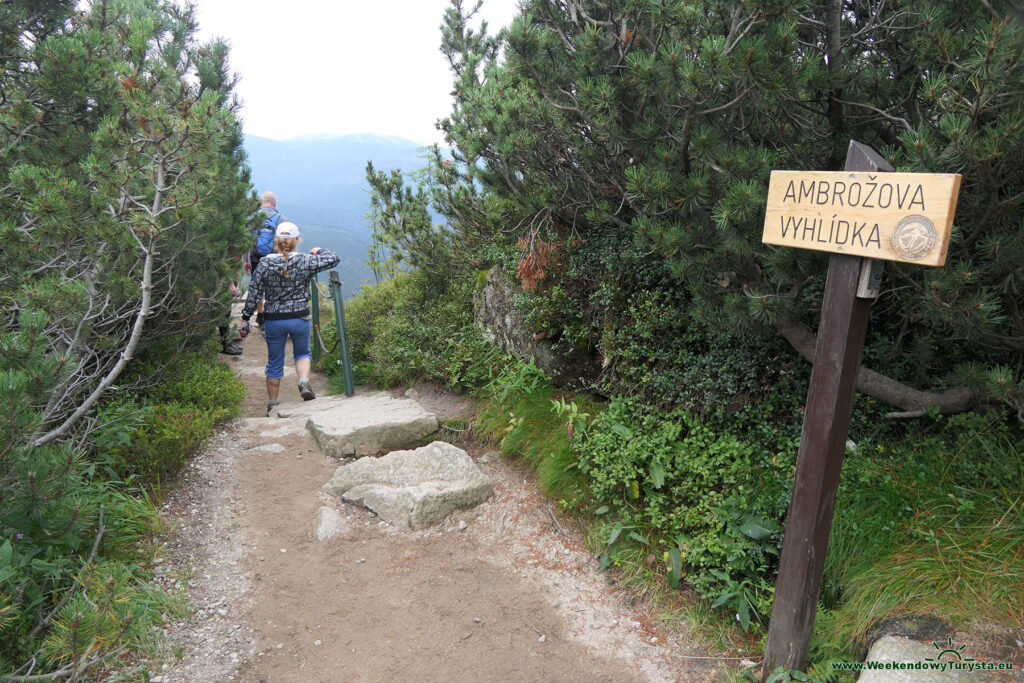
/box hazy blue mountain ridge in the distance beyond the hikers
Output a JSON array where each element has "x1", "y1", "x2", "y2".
[{"x1": 245, "y1": 133, "x2": 436, "y2": 298}]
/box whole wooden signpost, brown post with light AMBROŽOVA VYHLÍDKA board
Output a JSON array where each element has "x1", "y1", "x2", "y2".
[{"x1": 762, "y1": 140, "x2": 961, "y2": 680}]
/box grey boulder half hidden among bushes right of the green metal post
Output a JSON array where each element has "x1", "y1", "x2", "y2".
[{"x1": 473, "y1": 266, "x2": 601, "y2": 389}]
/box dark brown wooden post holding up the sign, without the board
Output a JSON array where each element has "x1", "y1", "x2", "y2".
[{"x1": 762, "y1": 141, "x2": 893, "y2": 680}]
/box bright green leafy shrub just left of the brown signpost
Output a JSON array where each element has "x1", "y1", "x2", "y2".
[{"x1": 574, "y1": 398, "x2": 792, "y2": 628}]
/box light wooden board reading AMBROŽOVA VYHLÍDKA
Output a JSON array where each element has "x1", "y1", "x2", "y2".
[{"x1": 761, "y1": 171, "x2": 961, "y2": 266}]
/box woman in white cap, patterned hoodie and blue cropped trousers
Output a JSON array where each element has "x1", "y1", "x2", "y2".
[{"x1": 239, "y1": 222, "x2": 340, "y2": 417}]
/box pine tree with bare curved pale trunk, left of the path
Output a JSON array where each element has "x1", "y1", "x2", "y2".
[{"x1": 0, "y1": 2, "x2": 252, "y2": 443}]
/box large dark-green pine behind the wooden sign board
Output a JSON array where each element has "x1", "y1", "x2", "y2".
[{"x1": 423, "y1": 0, "x2": 1024, "y2": 414}]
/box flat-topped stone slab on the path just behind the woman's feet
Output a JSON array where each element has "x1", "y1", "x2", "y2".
[{"x1": 294, "y1": 393, "x2": 438, "y2": 458}]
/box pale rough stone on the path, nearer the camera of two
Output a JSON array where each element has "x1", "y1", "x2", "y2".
[{"x1": 324, "y1": 441, "x2": 494, "y2": 529}]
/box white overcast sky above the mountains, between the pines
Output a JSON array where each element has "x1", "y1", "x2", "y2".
[{"x1": 196, "y1": 0, "x2": 517, "y2": 144}]
